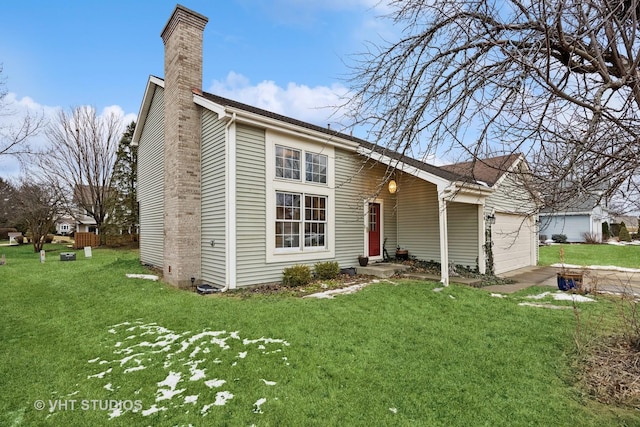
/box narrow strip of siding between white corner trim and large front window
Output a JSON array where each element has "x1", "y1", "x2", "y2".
[{"x1": 231, "y1": 124, "x2": 268, "y2": 286}]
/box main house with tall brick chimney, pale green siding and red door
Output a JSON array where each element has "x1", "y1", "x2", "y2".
[{"x1": 133, "y1": 5, "x2": 537, "y2": 288}]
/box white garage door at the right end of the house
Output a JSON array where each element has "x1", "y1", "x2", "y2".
[{"x1": 491, "y1": 213, "x2": 537, "y2": 274}]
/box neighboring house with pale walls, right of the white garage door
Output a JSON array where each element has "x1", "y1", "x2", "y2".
[{"x1": 540, "y1": 186, "x2": 611, "y2": 243}]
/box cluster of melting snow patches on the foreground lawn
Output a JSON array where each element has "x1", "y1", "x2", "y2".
[{"x1": 71, "y1": 319, "x2": 289, "y2": 419}]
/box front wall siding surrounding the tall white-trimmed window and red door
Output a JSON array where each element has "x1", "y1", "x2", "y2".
[{"x1": 236, "y1": 139, "x2": 396, "y2": 287}]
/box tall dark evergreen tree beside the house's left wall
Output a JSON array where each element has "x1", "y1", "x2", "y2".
[{"x1": 110, "y1": 122, "x2": 138, "y2": 233}]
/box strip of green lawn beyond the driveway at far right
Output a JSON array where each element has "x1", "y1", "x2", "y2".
[{"x1": 538, "y1": 244, "x2": 640, "y2": 268}]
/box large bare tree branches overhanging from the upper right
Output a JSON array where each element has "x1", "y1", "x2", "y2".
[{"x1": 349, "y1": 0, "x2": 640, "y2": 212}]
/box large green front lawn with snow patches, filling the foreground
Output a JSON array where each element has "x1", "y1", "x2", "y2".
[{"x1": 0, "y1": 245, "x2": 640, "y2": 426}]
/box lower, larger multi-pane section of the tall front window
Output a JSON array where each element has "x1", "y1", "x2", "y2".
[{"x1": 275, "y1": 192, "x2": 327, "y2": 250}]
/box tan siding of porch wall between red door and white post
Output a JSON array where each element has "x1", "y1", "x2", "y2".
[{"x1": 397, "y1": 174, "x2": 440, "y2": 261}]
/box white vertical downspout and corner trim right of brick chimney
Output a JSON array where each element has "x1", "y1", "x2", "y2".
[{"x1": 220, "y1": 112, "x2": 236, "y2": 292}]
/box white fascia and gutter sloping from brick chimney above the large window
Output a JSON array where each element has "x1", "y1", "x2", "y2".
[{"x1": 193, "y1": 94, "x2": 359, "y2": 151}]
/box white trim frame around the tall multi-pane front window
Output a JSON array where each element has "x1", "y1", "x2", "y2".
[{"x1": 265, "y1": 130, "x2": 336, "y2": 263}]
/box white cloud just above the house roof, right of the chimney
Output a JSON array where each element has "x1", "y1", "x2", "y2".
[{"x1": 207, "y1": 71, "x2": 348, "y2": 129}]
